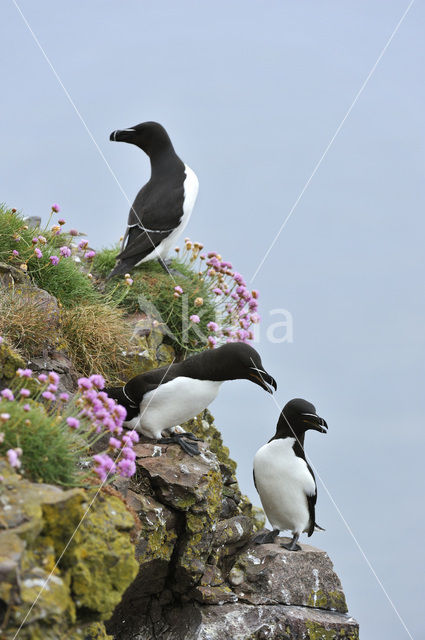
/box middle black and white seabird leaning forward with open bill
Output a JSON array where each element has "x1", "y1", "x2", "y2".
[{"x1": 105, "y1": 342, "x2": 277, "y2": 455}]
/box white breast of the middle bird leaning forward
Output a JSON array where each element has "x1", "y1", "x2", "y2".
[{"x1": 136, "y1": 376, "x2": 222, "y2": 438}]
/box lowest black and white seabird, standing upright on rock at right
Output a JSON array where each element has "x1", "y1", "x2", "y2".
[{"x1": 254, "y1": 398, "x2": 328, "y2": 551}]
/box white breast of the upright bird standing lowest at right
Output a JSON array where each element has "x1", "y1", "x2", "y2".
[{"x1": 254, "y1": 438, "x2": 316, "y2": 533}]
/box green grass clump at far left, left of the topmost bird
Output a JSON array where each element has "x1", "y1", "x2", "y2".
[{"x1": 0, "y1": 206, "x2": 100, "y2": 307}]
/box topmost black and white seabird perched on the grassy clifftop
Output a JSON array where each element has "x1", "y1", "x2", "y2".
[{"x1": 108, "y1": 122, "x2": 199, "y2": 278}]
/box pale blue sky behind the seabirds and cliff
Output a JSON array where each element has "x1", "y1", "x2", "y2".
[{"x1": 0, "y1": 0, "x2": 425, "y2": 640}]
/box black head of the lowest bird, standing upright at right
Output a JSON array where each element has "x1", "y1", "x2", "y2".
[{"x1": 276, "y1": 398, "x2": 328, "y2": 438}]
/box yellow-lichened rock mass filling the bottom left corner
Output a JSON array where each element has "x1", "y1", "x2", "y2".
[{"x1": 0, "y1": 462, "x2": 138, "y2": 640}]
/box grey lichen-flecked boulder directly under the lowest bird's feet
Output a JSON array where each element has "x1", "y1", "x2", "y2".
[{"x1": 229, "y1": 538, "x2": 347, "y2": 613}]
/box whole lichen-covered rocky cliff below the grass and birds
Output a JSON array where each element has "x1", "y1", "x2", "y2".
[{"x1": 0, "y1": 248, "x2": 358, "y2": 640}]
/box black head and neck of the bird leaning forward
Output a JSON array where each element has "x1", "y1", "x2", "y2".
[{"x1": 209, "y1": 342, "x2": 277, "y2": 393}]
